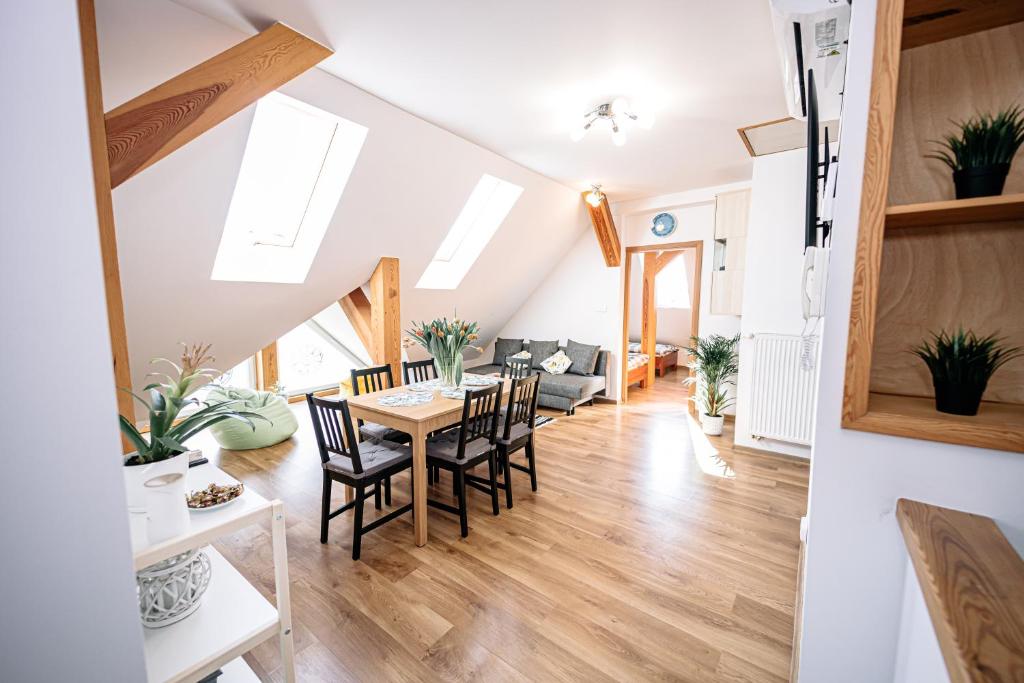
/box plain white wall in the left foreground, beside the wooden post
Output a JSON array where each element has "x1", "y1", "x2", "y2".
[{"x1": 0, "y1": 0, "x2": 145, "y2": 682}]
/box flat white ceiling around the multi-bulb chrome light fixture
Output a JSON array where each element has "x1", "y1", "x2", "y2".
[{"x1": 177, "y1": 0, "x2": 785, "y2": 200}]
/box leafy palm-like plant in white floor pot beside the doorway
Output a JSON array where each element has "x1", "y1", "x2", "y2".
[{"x1": 683, "y1": 335, "x2": 739, "y2": 436}]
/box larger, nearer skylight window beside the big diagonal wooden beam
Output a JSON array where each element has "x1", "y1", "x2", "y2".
[{"x1": 210, "y1": 92, "x2": 367, "y2": 283}]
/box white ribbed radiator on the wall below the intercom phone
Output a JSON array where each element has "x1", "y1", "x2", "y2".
[{"x1": 751, "y1": 334, "x2": 817, "y2": 445}]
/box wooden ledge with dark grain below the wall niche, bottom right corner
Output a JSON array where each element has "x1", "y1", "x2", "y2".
[{"x1": 896, "y1": 499, "x2": 1024, "y2": 683}]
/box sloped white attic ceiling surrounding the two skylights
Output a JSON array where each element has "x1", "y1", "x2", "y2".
[{"x1": 96, "y1": 0, "x2": 588, "y2": 411}]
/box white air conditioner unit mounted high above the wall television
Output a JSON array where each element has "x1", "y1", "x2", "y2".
[{"x1": 770, "y1": 0, "x2": 850, "y2": 121}]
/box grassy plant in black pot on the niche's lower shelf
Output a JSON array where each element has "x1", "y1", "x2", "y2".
[{"x1": 911, "y1": 327, "x2": 1022, "y2": 415}]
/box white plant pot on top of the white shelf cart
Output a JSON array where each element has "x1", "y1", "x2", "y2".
[{"x1": 123, "y1": 451, "x2": 197, "y2": 543}]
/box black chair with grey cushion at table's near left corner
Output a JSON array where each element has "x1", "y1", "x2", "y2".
[{"x1": 306, "y1": 393, "x2": 413, "y2": 560}]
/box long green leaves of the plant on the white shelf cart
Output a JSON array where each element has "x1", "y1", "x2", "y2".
[{"x1": 119, "y1": 344, "x2": 269, "y2": 465}]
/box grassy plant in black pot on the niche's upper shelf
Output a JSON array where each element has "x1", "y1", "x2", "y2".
[{"x1": 927, "y1": 105, "x2": 1024, "y2": 200}]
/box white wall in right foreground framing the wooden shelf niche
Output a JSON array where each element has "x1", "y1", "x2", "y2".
[{"x1": 800, "y1": 0, "x2": 1024, "y2": 683}]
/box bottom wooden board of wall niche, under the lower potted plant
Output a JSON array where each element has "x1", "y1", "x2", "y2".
[{"x1": 847, "y1": 392, "x2": 1024, "y2": 453}]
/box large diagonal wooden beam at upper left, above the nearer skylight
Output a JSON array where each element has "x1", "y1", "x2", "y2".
[{"x1": 104, "y1": 24, "x2": 333, "y2": 187}]
